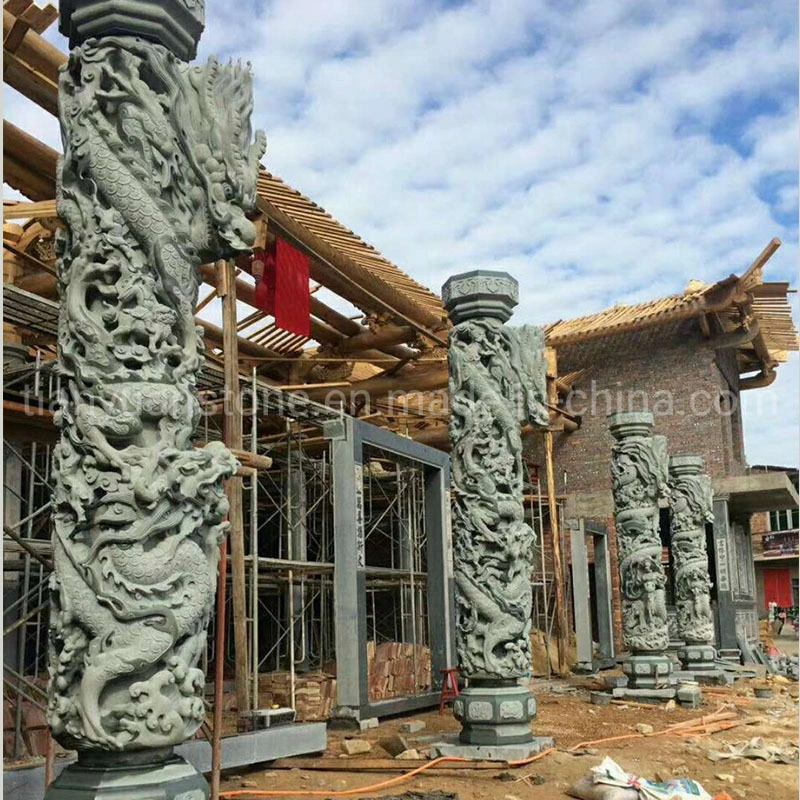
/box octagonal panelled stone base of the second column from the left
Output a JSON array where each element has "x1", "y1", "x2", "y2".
[{"x1": 453, "y1": 680, "x2": 536, "y2": 745}]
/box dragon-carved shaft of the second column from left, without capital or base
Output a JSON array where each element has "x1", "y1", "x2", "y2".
[{"x1": 448, "y1": 316, "x2": 548, "y2": 679}]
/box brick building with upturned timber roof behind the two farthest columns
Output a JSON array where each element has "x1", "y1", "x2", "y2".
[{"x1": 530, "y1": 261, "x2": 797, "y2": 664}]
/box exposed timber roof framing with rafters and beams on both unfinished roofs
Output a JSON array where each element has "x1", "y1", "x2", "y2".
[{"x1": 3, "y1": 0, "x2": 798, "y2": 444}]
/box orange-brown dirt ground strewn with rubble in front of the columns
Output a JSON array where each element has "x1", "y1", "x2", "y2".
[{"x1": 223, "y1": 678, "x2": 798, "y2": 800}]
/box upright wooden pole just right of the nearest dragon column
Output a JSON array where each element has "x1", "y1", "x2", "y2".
[{"x1": 217, "y1": 261, "x2": 250, "y2": 714}]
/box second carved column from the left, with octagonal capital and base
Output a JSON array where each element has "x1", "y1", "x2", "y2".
[{"x1": 439, "y1": 270, "x2": 552, "y2": 752}]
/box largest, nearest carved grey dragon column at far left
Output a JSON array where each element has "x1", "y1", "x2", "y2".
[{"x1": 47, "y1": 0, "x2": 264, "y2": 800}]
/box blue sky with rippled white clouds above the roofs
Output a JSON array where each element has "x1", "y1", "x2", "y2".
[{"x1": 5, "y1": 0, "x2": 800, "y2": 464}]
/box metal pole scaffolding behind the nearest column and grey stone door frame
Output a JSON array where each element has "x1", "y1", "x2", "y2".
[{"x1": 4, "y1": 350, "x2": 453, "y2": 776}]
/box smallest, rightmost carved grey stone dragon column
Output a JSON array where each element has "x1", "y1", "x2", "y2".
[{"x1": 669, "y1": 456, "x2": 716, "y2": 673}]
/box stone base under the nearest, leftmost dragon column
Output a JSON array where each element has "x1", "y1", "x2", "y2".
[{"x1": 44, "y1": 751, "x2": 209, "y2": 800}]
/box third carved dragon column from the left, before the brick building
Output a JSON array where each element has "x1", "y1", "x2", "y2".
[{"x1": 609, "y1": 412, "x2": 672, "y2": 689}]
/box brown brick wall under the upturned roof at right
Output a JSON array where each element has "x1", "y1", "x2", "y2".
[{"x1": 537, "y1": 321, "x2": 745, "y2": 493}]
